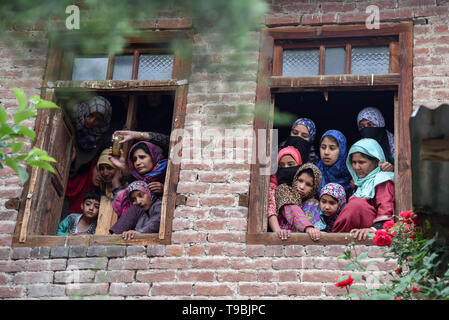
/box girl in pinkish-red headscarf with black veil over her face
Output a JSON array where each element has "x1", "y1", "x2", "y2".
[{"x1": 268, "y1": 147, "x2": 302, "y2": 240}]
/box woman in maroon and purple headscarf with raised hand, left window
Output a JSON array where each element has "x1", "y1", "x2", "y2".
[{"x1": 110, "y1": 141, "x2": 167, "y2": 217}]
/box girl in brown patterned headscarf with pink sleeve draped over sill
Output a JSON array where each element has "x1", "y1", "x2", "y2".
[{"x1": 275, "y1": 163, "x2": 324, "y2": 241}]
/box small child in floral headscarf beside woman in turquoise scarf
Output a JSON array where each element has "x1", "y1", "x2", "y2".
[{"x1": 320, "y1": 182, "x2": 346, "y2": 232}]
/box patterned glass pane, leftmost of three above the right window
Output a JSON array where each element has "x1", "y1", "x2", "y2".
[{"x1": 282, "y1": 49, "x2": 320, "y2": 76}]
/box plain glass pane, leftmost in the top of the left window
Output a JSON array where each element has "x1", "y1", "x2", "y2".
[{"x1": 72, "y1": 57, "x2": 108, "y2": 80}]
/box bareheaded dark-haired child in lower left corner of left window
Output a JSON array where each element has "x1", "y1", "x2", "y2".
[{"x1": 56, "y1": 189, "x2": 101, "y2": 236}]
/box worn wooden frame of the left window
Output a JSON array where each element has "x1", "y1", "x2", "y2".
[{"x1": 12, "y1": 30, "x2": 193, "y2": 247}]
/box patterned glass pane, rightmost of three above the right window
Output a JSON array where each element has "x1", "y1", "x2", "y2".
[{"x1": 351, "y1": 46, "x2": 390, "y2": 74}]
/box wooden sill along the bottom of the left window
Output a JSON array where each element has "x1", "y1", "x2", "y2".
[{"x1": 12, "y1": 233, "x2": 171, "y2": 248}]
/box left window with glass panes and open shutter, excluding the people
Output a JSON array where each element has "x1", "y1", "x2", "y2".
[{"x1": 13, "y1": 31, "x2": 192, "y2": 247}]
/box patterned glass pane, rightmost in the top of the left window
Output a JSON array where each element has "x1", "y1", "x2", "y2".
[{"x1": 137, "y1": 54, "x2": 174, "y2": 80}]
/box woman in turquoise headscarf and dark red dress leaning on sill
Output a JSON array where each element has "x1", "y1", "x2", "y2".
[{"x1": 332, "y1": 138, "x2": 394, "y2": 240}]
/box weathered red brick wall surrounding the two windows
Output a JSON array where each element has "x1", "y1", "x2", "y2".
[{"x1": 0, "y1": 0, "x2": 449, "y2": 299}]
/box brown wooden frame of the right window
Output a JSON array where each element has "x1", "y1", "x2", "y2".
[{"x1": 246, "y1": 22, "x2": 413, "y2": 245}]
